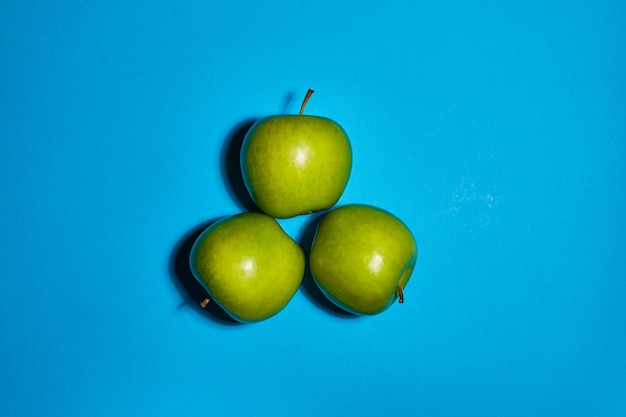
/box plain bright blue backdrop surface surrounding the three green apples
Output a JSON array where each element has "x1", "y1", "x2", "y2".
[{"x1": 0, "y1": 0, "x2": 626, "y2": 416}]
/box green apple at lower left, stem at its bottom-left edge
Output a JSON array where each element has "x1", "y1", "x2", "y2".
[{"x1": 189, "y1": 213, "x2": 305, "y2": 323}]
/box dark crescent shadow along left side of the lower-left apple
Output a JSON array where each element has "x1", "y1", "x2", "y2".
[{"x1": 169, "y1": 217, "x2": 241, "y2": 325}]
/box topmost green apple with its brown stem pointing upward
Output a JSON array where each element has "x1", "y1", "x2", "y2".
[{"x1": 241, "y1": 90, "x2": 352, "y2": 219}]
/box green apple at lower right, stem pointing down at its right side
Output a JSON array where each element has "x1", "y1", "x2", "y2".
[{"x1": 309, "y1": 204, "x2": 417, "y2": 315}]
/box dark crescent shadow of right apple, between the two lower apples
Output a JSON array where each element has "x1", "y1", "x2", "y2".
[{"x1": 297, "y1": 212, "x2": 360, "y2": 318}]
